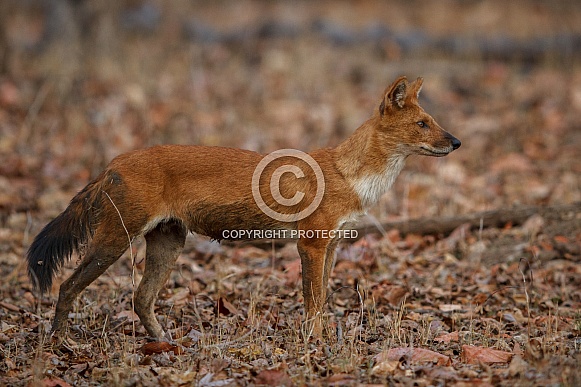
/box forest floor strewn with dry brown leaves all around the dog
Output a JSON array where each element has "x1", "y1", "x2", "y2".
[{"x1": 0, "y1": 1, "x2": 581, "y2": 386}]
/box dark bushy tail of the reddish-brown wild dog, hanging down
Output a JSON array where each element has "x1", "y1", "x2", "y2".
[{"x1": 27, "y1": 173, "x2": 105, "y2": 293}]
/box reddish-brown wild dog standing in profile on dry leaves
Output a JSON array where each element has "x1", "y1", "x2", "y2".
[{"x1": 27, "y1": 77, "x2": 460, "y2": 338}]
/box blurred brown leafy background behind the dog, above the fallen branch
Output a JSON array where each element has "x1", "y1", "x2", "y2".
[{"x1": 0, "y1": 0, "x2": 581, "y2": 224}]
